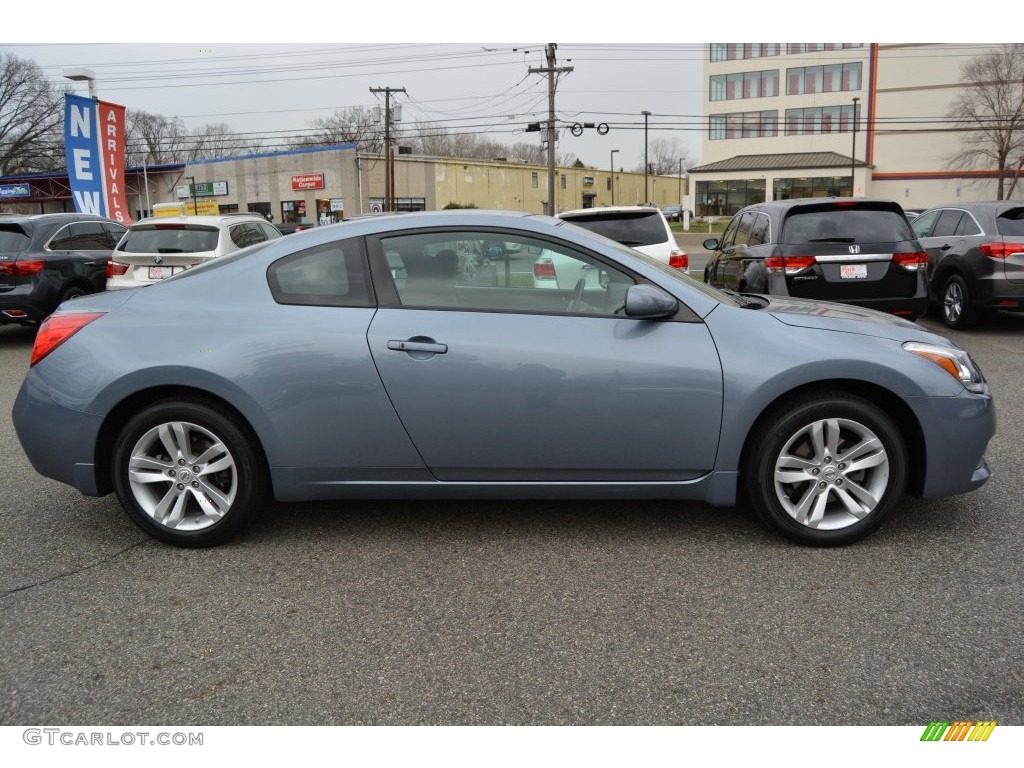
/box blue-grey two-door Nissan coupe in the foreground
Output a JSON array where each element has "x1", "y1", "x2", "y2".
[{"x1": 12, "y1": 210, "x2": 995, "y2": 547}]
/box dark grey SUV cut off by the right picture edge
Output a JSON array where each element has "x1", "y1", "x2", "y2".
[{"x1": 911, "y1": 201, "x2": 1024, "y2": 329}]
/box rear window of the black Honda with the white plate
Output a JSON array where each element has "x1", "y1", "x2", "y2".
[{"x1": 780, "y1": 208, "x2": 914, "y2": 245}]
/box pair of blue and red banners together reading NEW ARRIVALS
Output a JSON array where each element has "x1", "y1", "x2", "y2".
[{"x1": 65, "y1": 93, "x2": 131, "y2": 224}]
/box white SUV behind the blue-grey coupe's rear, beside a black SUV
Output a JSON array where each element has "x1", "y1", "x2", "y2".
[{"x1": 106, "y1": 213, "x2": 282, "y2": 291}]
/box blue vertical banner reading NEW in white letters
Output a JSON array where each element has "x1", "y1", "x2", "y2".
[{"x1": 65, "y1": 93, "x2": 109, "y2": 216}]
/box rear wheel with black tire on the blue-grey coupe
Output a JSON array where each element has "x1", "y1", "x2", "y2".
[{"x1": 112, "y1": 399, "x2": 267, "y2": 547}]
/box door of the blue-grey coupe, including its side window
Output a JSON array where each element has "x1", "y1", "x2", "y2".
[{"x1": 368, "y1": 225, "x2": 722, "y2": 482}]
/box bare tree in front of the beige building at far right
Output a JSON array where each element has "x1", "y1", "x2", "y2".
[{"x1": 949, "y1": 43, "x2": 1024, "y2": 200}]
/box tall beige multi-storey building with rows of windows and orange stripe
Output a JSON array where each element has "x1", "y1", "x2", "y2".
[{"x1": 690, "y1": 43, "x2": 995, "y2": 215}]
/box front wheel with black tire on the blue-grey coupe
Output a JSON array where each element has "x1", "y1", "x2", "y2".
[{"x1": 741, "y1": 392, "x2": 907, "y2": 547}]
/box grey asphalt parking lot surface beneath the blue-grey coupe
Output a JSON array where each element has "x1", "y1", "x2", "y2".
[{"x1": 0, "y1": 315, "x2": 1024, "y2": 727}]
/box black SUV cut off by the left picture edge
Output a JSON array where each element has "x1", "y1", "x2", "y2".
[{"x1": 0, "y1": 213, "x2": 127, "y2": 325}]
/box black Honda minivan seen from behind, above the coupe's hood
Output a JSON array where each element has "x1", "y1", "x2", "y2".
[{"x1": 703, "y1": 198, "x2": 929, "y2": 319}]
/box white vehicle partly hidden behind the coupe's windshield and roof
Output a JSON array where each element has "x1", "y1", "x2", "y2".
[{"x1": 558, "y1": 206, "x2": 689, "y2": 269}]
